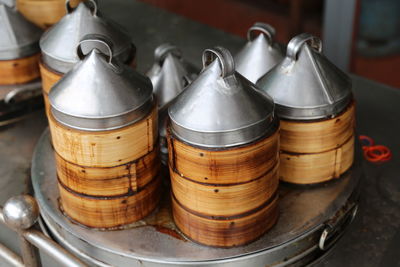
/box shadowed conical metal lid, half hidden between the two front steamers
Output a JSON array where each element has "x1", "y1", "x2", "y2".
[{"x1": 146, "y1": 44, "x2": 199, "y2": 108}]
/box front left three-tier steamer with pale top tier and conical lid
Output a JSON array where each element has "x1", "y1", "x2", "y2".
[{"x1": 49, "y1": 35, "x2": 160, "y2": 228}]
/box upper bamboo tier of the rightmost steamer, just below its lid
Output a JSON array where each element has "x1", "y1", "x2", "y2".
[{"x1": 280, "y1": 102, "x2": 355, "y2": 153}]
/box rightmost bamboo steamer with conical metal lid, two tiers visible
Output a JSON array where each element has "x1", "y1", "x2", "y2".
[{"x1": 257, "y1": 34, "x2": 355, "y2": 184}]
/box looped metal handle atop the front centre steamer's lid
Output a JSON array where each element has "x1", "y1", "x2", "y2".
[{"x1": 203, "y1": 46, "x2": 235, "y2": 78}]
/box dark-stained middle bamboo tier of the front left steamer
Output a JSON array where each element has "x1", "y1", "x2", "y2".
[{"x1": 55, "y1": 148, "x2": 160, "y2": 196}]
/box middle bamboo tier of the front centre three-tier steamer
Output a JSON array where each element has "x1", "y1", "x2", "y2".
[{"x1": 170, "y1": 164, "x2": 279, "y2": 216}]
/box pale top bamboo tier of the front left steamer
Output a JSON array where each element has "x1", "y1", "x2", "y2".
[{"x1": 48, "y1": 105, "x2": 158, "y2": 167}]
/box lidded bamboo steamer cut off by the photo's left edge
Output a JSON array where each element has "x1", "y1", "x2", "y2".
[{"x1": 0, "y1": 3, "x2": 42, "y2": 86}]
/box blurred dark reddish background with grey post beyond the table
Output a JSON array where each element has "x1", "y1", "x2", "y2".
[{"x1": 140, "y1": 0, "x2": 400, "y2": 88}]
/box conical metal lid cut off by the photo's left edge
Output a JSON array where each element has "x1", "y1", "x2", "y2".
[{"x1": 0, "y1": 1, "x2": 42, "y2": 60}]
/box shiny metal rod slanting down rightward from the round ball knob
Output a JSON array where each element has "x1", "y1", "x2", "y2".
[{"x1": 24, "y1": 230, "x2": 87, "y2": 267}]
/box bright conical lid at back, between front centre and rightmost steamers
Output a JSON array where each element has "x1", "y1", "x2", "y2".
[{"x1": 235, "y1": 22, "x2": 284, "y2": 83}]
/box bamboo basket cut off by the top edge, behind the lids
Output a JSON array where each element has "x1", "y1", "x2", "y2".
[{"x1": 16, "y1": 0, "x2": 81, "y2": 29}]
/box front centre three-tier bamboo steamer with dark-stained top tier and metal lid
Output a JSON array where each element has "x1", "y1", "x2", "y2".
[{"x1": 168, "y1": 47, "x2": 279, "y2": 247}]
